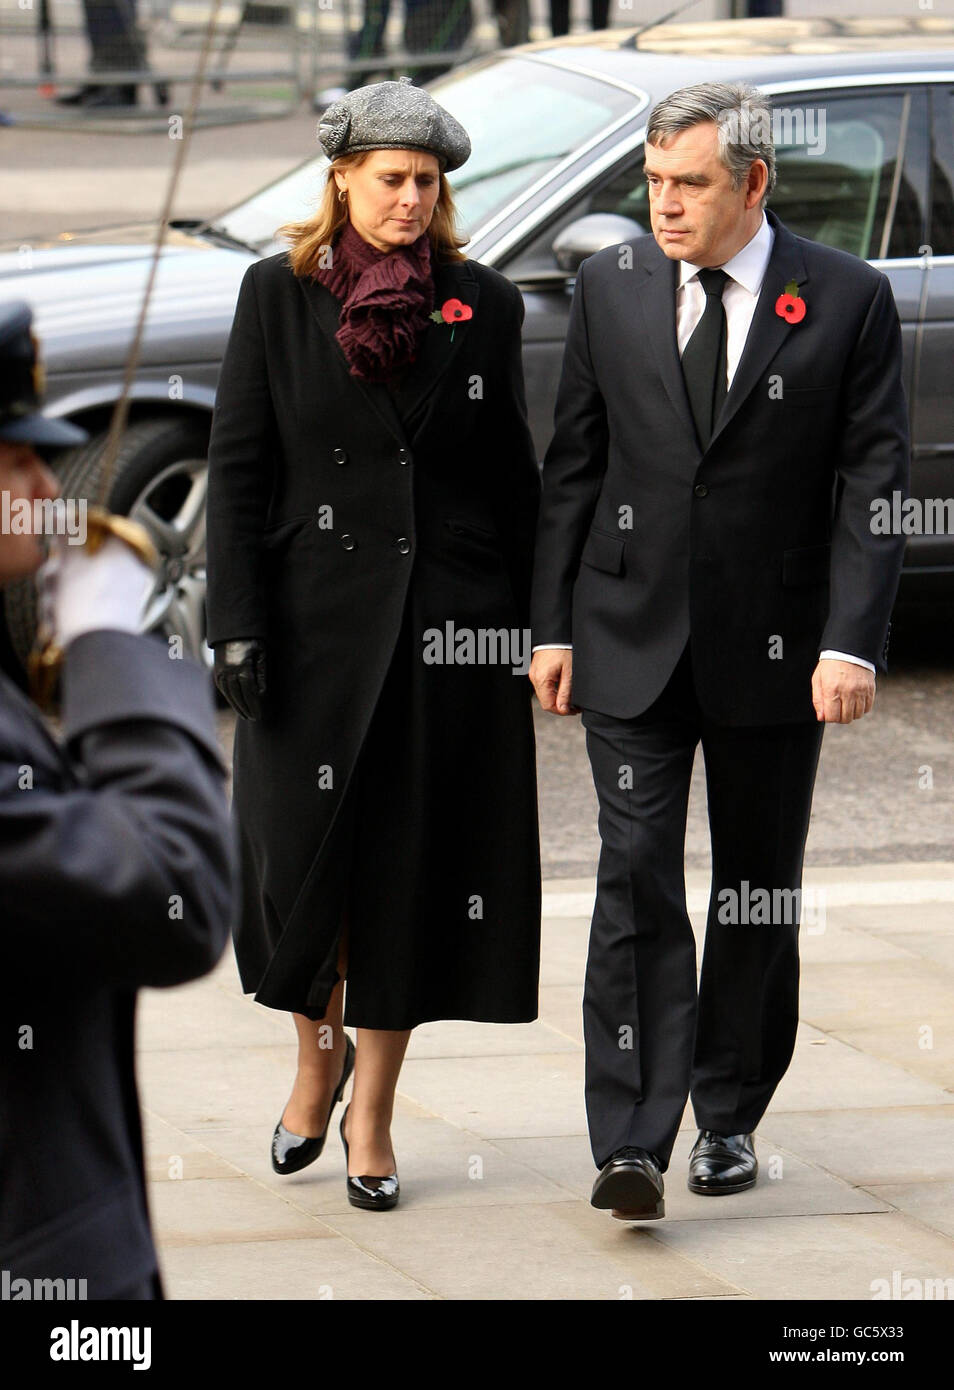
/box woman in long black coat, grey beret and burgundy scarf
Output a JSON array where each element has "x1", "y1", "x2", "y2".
[{"x1": 209, "y1": 81, "x2": 540, "y2": 1208}]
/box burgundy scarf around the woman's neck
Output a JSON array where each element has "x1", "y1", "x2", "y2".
[{"x1": 313, "y1": 221, "x2": 434, "y2": 381}]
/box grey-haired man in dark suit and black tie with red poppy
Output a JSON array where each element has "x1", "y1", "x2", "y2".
[{"x1": 530, "y1": 83, "x2": 909, "y2": 1219}]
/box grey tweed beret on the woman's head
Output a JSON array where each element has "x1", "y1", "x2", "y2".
[{"x1": 318, "y1": 78, "x2": 470, "y2": 171}]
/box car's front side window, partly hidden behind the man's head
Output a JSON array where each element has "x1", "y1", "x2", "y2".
[{"x1": 506, "y1": 92, "x2": 928, "y2": 279}]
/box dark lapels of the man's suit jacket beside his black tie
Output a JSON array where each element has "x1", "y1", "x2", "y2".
[{"x1": 637, "y1": 210, "x2": 808, "y2": 448}]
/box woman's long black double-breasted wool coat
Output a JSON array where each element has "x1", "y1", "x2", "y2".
[{"x1": 209, "y1": 239, "x2": 540, "y2": 1029}]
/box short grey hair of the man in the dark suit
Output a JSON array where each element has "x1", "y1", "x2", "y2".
[{"x1": 645, "y1": 82, "x2": 775, "y2": 206}]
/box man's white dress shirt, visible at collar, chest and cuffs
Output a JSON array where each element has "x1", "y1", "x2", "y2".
[{"x1": 534, "y1": 213, "x2": 875, "y2": 674}]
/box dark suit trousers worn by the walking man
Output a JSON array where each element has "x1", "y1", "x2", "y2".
[{"x1": 583, "y1": 646, "x2": 823, "y2": 1170}]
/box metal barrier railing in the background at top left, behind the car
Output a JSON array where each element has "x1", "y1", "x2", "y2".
[{"x1": 0, "y1": 0, "x2": 514, "y2": 129}]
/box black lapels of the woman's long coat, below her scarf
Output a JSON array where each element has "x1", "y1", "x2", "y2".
[{"x1": 299, "y1": 252, "x2": 478, "y2": 443}]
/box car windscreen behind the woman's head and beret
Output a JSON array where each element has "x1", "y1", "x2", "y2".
[{"x1": 216, "y1": 54, "x2": 648, "y2": 254}]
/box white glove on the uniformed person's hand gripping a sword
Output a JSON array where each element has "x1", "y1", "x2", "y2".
[{"x1": 36, "y1": 535, "x2": 156, "y2": 649}]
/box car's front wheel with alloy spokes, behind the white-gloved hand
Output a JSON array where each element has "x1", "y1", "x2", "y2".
[{"x1": 6, "y1": 420, "x2": 213, "y2": 670}]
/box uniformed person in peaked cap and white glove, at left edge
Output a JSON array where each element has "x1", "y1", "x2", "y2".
[{"x1": 0, "y1": 303, "x2": 236, "y2": 1298}]
